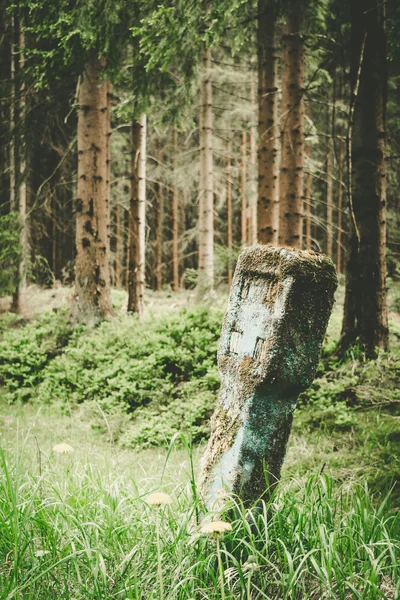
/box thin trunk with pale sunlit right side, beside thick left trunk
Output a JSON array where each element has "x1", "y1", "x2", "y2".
[{"x1": 128, "y1": 115, "x2": 146, "y2": 316}]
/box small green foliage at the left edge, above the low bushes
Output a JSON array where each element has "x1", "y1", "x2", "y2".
[{"x1": 0, "y1": 213, "x2": 21, "y2": 296}]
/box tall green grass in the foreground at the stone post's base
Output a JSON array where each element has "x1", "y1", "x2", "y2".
[{"x1": 0, "y1": 438, "x2": 400, "y2": 600}]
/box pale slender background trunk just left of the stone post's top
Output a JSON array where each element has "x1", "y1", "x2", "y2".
[{"x1": 199, "y1": 50, "x2": 214, "y2": 288}]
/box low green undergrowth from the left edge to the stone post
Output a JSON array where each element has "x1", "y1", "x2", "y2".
[{"x1": 0, "y1": 307, "x2": 222, "y2": 448}]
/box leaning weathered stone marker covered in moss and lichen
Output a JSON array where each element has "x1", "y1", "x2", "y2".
[{"x1": 200, "y1": 246, "x2": 337, "y2": 510}]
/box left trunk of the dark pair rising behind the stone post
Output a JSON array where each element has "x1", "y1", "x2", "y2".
[{"x1": 257, "y1": 0, "x2": 280, "y2": 244}]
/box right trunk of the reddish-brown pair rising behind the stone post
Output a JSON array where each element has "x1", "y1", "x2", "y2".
[{"x1": 279, "y1": 2, "x2": 304, "y2": 248}]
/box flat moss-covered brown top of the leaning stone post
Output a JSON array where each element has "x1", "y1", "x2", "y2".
[{"x1": 236, "y1": 244, "x2": 337, "y2": 287}]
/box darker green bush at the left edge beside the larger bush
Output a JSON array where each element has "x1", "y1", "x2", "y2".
[{"x1": 0, "y1": 311, "x2": 80, "y2": 401}]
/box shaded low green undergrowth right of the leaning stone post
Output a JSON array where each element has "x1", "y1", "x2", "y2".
[{"x1": 294, "y1": 323, "x2": 400, "y2": 506}]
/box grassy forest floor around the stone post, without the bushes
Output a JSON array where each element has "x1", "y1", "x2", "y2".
[{"x1": 0, "y1": 286, "x2": 400, "y2": 600}]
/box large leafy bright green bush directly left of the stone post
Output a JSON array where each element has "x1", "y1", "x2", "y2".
[{"x1": 38, "y1": 308, "x2": 221, "y2": 448}]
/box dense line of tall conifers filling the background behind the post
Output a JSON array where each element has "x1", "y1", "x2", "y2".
[{"x1": 0, "y1": 0, "x2": 400, "y2": 354}]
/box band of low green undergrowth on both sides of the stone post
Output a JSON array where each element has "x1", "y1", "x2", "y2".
[{"x1": 0, "y1": 295, "x2": 400, "y2": 448}]
